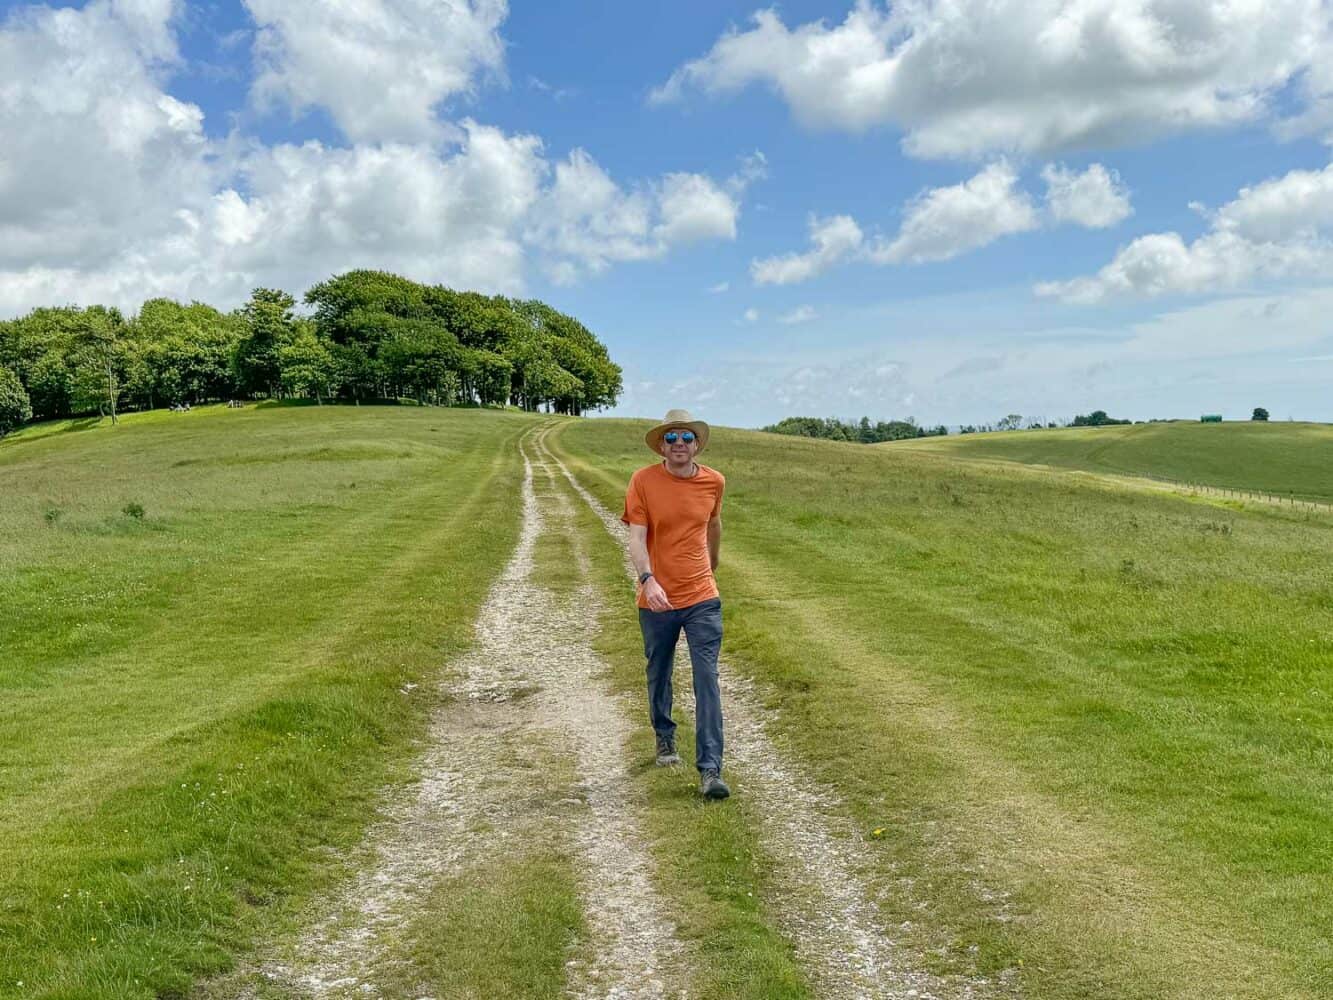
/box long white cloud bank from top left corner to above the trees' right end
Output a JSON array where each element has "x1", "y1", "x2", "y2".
[{"x1": 0, "y1": 0, "x2": 762, "y2": 315}]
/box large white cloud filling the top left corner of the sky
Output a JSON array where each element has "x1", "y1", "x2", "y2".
[{"x1": 0, "y1": 0, "x2": 213, "y2": 269}]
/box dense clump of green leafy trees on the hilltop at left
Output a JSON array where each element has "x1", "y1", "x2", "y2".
[{"x1": 0, "y1": 271, "x2": 621, "y2": 435}]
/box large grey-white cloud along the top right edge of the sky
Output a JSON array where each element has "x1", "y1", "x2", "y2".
[{"x1": 651, "y1": 0, "x2": 1333, "y2": 156}]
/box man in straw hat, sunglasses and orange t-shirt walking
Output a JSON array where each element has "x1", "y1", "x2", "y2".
[{"x1": 621, "y1": 409, "x2": 730, "y2": 799}]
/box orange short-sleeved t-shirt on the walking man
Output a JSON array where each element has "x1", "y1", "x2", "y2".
[{"x1": 620, "y1": 461, "x2": 726, "y2": 608}]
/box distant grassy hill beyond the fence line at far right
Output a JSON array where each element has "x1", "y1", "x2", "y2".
[{"x1": 882, "y1": 421, "x2": 1333, "y2": 500}]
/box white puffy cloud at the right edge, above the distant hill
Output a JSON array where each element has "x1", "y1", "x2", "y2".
[{"x1": 1034, "y1": 165, "x2": 1333, "y2": 304}]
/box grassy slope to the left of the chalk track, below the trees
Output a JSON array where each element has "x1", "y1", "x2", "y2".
[{"x1": 0, "y1": 407, "x2": 535, "y2": 997}]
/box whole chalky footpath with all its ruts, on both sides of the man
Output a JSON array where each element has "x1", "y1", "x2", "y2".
[{"x1": 209, "y1": 425, "x2": 993, "y2": 1000}]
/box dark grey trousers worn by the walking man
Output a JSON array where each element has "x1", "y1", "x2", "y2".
[{"x1": 639, "y1": 597, "x2": 722, "y2": 771}]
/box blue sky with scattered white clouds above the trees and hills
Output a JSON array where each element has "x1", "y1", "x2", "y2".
[{"x1": 0, "y1": 0, "x2": 1333, "y2": 427}]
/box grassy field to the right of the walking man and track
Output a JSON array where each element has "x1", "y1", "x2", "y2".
[{"x1": 559, "y1": 420, "x2": 1333, "y2": 1000}]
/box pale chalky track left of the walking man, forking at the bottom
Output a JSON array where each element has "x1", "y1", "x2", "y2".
[{"x1": 247, "y1": 428, "x2": 688, "y2": 1000}]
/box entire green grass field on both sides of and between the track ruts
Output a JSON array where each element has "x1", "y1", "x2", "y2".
[{"x1": 0, "y1": 407, "x2": 1333, "y2": 1000}]
